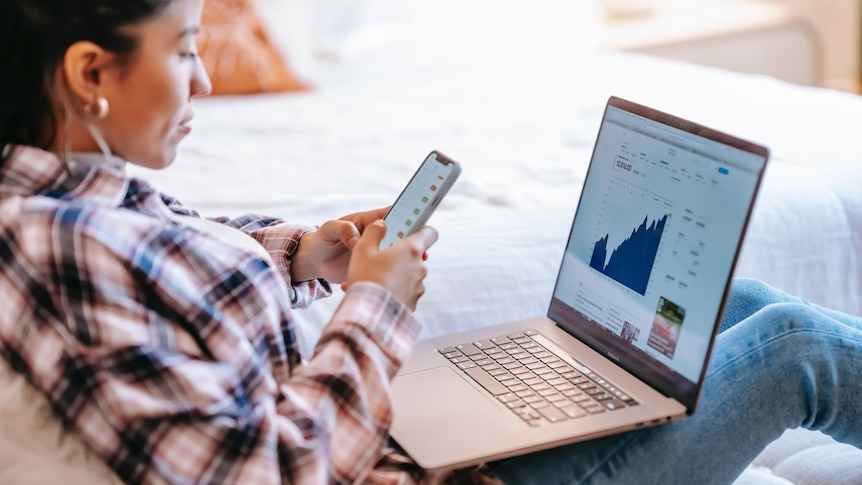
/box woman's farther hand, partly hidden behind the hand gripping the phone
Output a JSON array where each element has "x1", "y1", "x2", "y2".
[{"x1": 290, "y1": 207, "x2": 389, "y2": 283}]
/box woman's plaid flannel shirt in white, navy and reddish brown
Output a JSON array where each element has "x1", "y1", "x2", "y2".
[{"x1": 0, "y1": 147, "x2": 500, "y2": 484}]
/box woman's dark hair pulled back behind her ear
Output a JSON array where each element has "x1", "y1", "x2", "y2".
[{"x1": 0, "y1": 0, "x2": 173, "y2": 163}]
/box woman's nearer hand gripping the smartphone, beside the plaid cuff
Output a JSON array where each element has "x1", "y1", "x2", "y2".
[{"x1": 341, "y1": 221, "x2": 437, "y2": 310}]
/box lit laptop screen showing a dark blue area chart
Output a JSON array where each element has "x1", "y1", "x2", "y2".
[{"x1": 548, "y1": 98, "x2": 768, "y2": 413}]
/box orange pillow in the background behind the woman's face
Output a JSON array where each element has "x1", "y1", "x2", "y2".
[{"x1": 198, "y1": 0, "x2": 308, "y2": 95}]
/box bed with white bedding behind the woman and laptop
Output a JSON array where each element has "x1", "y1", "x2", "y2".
[{"x1": 5, "y1": 1, "x2": 862, "y2": 484}]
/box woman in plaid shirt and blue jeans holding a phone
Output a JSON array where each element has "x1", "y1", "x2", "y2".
[{"x1": 0, "y1": 0, "x2": 862, "y2": 483}]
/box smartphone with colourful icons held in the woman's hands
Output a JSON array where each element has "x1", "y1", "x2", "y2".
[{"x1": 380, "y1": 150, "x2": 461, "y2": 249}]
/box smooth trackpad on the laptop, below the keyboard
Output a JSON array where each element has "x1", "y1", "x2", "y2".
[{"x1": 392, "y1": 367, "x2": 505, "y2": 428}]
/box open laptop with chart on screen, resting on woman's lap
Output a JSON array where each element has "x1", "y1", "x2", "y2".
[{"x1": 390, "y1": 97, "x2": 769, "y2": 470}]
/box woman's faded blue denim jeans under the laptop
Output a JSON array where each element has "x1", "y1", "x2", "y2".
[{"x1": 490, "y1": 279, "x2": 862, "y2": 485}]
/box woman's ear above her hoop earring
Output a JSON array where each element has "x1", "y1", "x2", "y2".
[{"x1": 63, "y1": 41, "x2": 115, "y2": 103}]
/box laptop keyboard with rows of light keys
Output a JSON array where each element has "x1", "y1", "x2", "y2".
[{"x1": 438, "y1": 330, "x2": 638, "y2": 426}]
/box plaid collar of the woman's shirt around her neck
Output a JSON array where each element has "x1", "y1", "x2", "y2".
[{"x1": 0, "y1": 146, "x2": 128, "y2": 207}]
